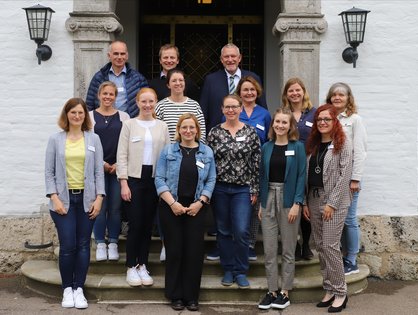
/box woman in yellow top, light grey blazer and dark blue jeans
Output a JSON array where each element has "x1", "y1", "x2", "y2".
[{"x1": 45, "y1": 98, "x2": 105, "y2": 308}]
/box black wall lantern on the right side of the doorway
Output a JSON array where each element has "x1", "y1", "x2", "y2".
[{"x1": 338, "y1": 7, "x2": 370, "y2": 68}]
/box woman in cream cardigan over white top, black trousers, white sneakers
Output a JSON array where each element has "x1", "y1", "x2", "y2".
[{"x1": 116, "y1": 88, "x2": 170, "y2": 286}]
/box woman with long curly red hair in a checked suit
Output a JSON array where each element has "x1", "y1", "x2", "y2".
[{"x1": 304, "y1": 104, "x2": 352, "y2": 313}]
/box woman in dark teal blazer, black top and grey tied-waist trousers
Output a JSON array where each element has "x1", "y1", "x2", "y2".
[{"x1": 258, "y1": 108, "x2": 306, "y2": 309}]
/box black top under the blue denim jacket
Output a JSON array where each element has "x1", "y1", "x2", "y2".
[{"x1": 178, "y1": 146, "x2": 199, "y2": 199}]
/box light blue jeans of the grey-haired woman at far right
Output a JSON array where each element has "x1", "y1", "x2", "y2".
[{"x1": 342, "y1": 192, "x2": 360, "y2": 264}]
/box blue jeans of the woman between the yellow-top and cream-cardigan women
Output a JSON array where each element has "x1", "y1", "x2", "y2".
[{"x1": 93, "y1": 173, "x2": 122, "y2": 243}]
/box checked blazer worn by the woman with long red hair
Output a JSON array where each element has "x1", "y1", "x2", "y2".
[{"x1": 306, "y1": 138, "x2": 353, "y2": 210}]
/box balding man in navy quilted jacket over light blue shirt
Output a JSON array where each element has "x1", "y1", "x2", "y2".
[{"x1": 86, "y1": 41, "x2": 148, "y2": 117}]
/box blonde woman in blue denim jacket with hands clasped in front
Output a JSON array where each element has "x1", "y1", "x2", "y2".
[{"x1": 155, "y1": 113, "x2": 216, "y2": 311}]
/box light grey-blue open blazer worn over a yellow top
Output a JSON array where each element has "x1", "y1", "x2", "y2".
[{"x1": 45, "y1": 131, "x2": 105, "y2": 212}]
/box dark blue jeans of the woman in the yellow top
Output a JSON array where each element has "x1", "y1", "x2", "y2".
[{"x1": 50, "y1": 193, "x2": 94, "y2": 289}]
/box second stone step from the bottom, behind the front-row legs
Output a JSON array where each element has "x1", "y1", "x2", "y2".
[{"x1": 54, "y1": 247, "x2": 319, "y2": 277}]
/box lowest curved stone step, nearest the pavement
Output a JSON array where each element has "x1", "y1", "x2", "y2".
[{"x1": 21, "y1": 260, "x2": 370, "y2": 305}]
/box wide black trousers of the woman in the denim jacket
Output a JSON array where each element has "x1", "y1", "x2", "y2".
[{"x1": 159, "y1": 198, "x2": 206, "y2": 303}]
